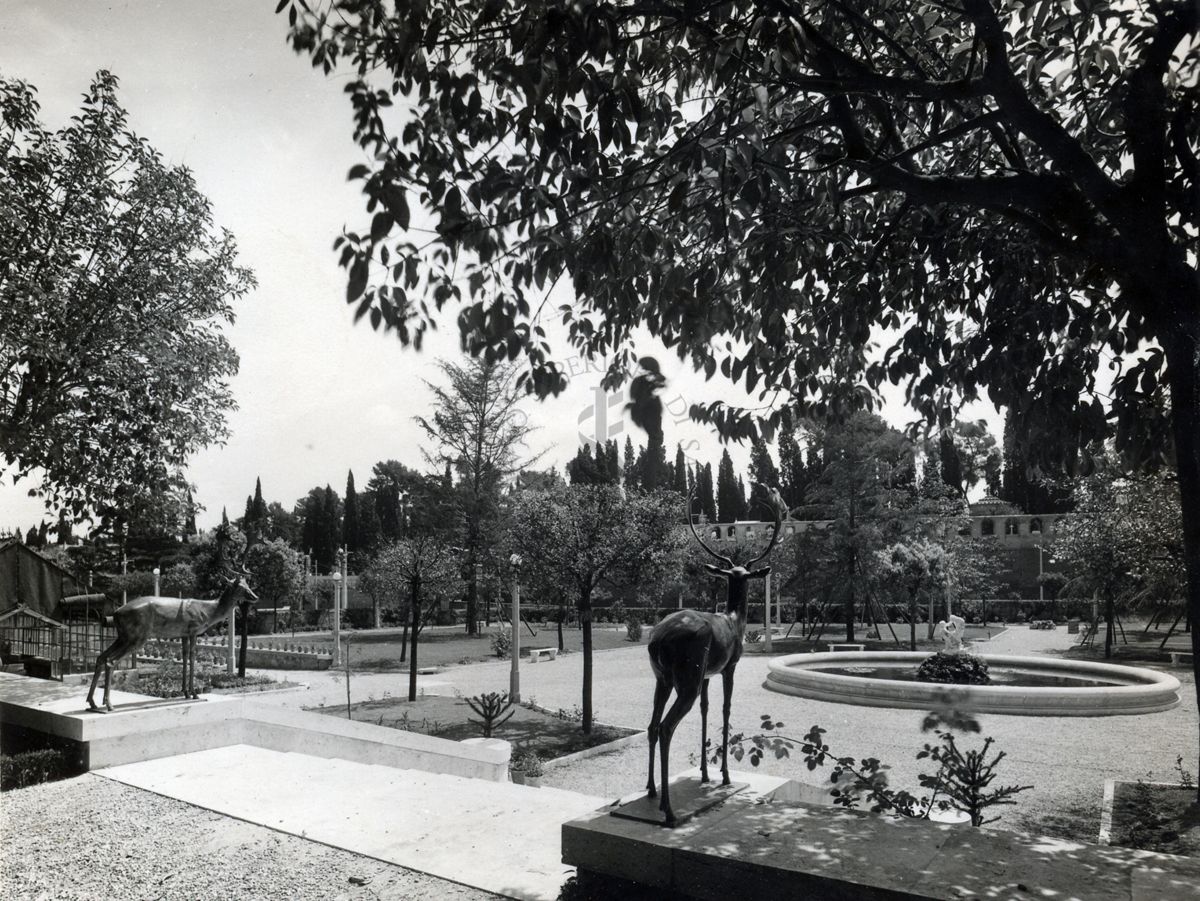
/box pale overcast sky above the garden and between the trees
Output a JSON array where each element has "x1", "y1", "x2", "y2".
[{"x1": 0, "y1": 0, "x2": 993, "y2": 528}]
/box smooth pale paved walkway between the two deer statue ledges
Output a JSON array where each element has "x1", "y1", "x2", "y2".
[{"x1": 96, "y1": 745, "x2": 606, "y2": 901}]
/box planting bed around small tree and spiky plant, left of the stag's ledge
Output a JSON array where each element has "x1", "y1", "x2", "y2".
[{"x1": 313, "y1": 696, "x2": 637, "y2": 761}]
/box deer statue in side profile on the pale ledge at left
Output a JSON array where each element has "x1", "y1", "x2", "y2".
[{"x1": 88, "y1": 570, "x2": 258, "y2": 713}]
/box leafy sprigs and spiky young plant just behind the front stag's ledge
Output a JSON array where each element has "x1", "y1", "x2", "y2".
[{"x1": 706, "y1": 711, "x2": 1033, "y2": 827}]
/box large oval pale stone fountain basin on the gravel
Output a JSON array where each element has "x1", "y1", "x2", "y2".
[{"x1": 764, "y1": 651, "x2": 1180, "y2": 716}]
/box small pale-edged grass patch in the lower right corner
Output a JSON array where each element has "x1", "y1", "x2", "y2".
[{"x1": 1111, "y1": 782, "x2": 1200, "y2": 857}]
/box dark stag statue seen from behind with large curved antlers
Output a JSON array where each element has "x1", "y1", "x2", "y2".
[{"x1": 646, "y1": 482, "x2": 785, "y2": 825}]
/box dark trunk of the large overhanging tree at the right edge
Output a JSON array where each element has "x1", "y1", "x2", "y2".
[{"x1": 1160, "y1": 311, "x2": 1200, "y2": 799}]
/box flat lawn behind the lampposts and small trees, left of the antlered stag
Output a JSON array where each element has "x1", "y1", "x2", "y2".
[{"x1": 254, "y1": 625, "x2": 649, "y2": 673}]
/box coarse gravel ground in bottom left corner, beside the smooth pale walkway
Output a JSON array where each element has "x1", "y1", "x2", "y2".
[{"x1": 0, "y1": 775, "x2": 498, "y2": 901}]
